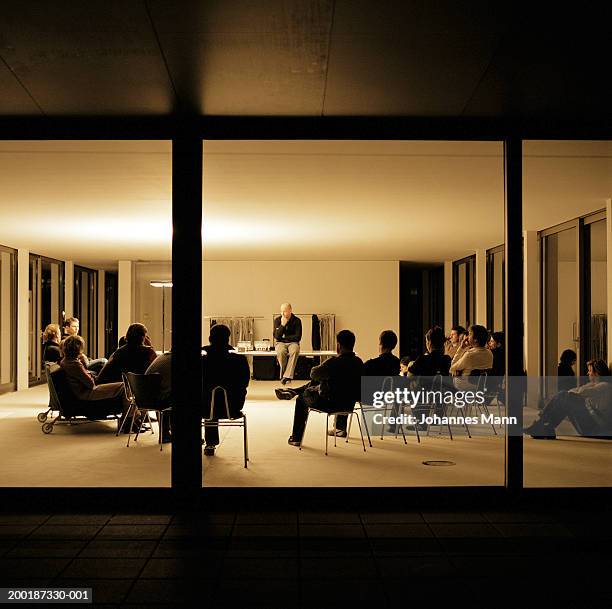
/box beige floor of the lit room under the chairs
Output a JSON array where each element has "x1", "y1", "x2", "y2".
[{"x1": 0, "y1": 381, "x2": 612, "y2": 487}]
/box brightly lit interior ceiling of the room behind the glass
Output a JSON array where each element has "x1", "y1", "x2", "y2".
[{"x1": 0, "y1": 141, "x2": 612, "y2": 268}]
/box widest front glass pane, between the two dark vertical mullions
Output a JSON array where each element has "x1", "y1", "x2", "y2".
[{"x1": 203, "y1": 141, "x2": 505, "y2": 487}]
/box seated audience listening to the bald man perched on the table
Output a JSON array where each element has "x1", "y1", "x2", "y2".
[{"x1": 44, "y1": 318, "x2": 612, "y2": 456}]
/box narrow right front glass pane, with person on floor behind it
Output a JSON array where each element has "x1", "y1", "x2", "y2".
[{"x1": 520, "y1": 140, "x2": 612, "y2": 488}]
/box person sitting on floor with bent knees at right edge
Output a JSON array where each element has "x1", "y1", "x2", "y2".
[{"x1": 523, "y1": 360, "x2": 612, "y2": 440}]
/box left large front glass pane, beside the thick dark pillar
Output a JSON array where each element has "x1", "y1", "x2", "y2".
[{"x1": 0, "y1": 140, "x2": 172, "y2": 488}]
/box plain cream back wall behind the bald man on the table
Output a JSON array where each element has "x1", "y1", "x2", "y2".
[{"x1": 202, "y1": 260, "x2": 399, "y2": 359}]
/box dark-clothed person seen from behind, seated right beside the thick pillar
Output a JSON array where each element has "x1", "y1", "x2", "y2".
[{"x1": 202, "y1": 324, "x2": 251, "y2": 456}]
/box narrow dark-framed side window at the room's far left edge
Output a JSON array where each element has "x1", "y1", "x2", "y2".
[{"x1": 0, "y1": 245, "x2": 17, "y2": 393}]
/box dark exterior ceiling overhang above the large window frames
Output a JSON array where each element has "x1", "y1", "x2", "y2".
[{"x1": 0, "y1": 0, "x2": 612, "y2": 119}]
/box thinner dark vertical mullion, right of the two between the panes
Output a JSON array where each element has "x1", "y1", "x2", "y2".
[{"x1": 504, "y1": 138, "x2": 524, "y2": 495}]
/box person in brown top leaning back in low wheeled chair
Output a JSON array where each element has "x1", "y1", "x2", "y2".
[{"x1": 60, "y1": 335, "x2": 129, "y2": 432}]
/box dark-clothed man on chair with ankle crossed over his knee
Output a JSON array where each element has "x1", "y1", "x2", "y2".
[{"x1": 276, "y1": 330, "x2": 363, "y2": 446}]
